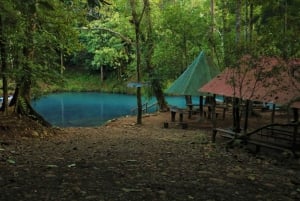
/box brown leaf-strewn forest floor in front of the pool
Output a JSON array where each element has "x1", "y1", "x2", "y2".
[{"x1": 0, "y1": 112, "x2": 300, "y2": 201}]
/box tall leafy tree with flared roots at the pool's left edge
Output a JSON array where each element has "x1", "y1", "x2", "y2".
[{"x1": 0, "y1": 0, "x2": 83, "y2": 125}]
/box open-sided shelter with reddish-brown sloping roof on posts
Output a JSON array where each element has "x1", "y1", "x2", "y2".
[{"x1": 199, "y1": 56, "x2": 300, "y2": 154}]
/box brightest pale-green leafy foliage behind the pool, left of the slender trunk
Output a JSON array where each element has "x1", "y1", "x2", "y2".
[{"x1": 77, "y1": 4, "x2": 131, "y2": 78}]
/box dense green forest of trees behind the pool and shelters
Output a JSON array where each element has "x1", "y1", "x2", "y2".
[{"x1": 0, "y1": 0, "x2": 300, "y2": 125}]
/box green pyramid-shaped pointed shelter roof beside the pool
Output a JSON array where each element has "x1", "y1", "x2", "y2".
[{"x1": 165, "y1": 51, "x2": 219, "y2": 113}]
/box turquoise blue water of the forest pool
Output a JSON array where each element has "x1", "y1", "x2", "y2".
[{"x1": 32, "y1": 92, "x2": 204, "y2": 127}]
